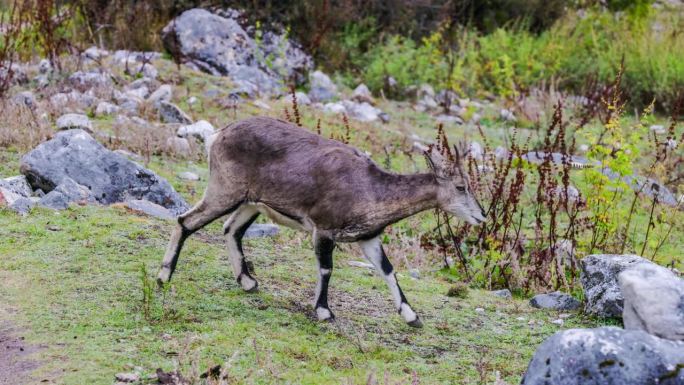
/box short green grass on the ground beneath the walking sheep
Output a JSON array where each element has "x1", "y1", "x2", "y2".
[{"x1": 0, "y1": 202, "x2": 608, "y2": 384}]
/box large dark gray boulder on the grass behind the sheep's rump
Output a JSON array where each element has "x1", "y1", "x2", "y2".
[{"x1": 20, "y1": 129, "x2": 188, "y2": 215}]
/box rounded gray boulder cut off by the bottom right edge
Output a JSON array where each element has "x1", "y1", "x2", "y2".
[{"x1": 521, "y1": 327, "x2": 684, "y2": 385}]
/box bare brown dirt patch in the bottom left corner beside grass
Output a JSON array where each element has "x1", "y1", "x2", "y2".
[{"x1": 0, "y1": 322, "x2": 40, "y2": 385}]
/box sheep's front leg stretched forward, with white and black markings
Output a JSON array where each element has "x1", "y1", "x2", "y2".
[{"x1": 359, "y1": 237, "x2": 423, "y2": 328}]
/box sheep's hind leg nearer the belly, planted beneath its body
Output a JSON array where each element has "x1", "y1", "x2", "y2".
[{"x1": 223, "y1": 204, "x2": 259, "y2": 292}]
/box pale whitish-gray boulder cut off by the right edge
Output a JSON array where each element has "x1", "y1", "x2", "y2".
[{"x1": 618, "y1": 263, "x2": 684, "y2": 340}]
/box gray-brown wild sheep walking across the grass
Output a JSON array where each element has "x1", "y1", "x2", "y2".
[{"x1": 159, "y1": 117, "x2": 484, "y2": 323}]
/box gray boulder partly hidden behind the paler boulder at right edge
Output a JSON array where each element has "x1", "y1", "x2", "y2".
[{"x1": 580, "y1": 254, "x2": 652, "y2": 318}]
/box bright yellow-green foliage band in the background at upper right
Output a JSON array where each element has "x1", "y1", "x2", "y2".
[{"x1": 362, "y1": 11, "x2": 684, "y2": 106}]
